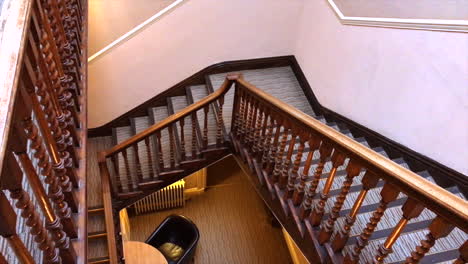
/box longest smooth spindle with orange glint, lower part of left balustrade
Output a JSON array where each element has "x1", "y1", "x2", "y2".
[{"x1": 19, "y1": 153, "x2": 76, "y2": 263}]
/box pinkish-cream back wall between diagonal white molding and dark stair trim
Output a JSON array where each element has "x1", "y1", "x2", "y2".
[{"x1": 88, "y1": 0, "x2": 303, "y2": 128}]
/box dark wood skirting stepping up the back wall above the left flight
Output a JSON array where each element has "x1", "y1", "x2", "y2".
[{"x1": 88, "y1": 55, "x2": 294, "y2": 137}]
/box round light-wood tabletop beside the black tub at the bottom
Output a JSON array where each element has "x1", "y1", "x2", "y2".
[{"x1": 124, "y1": 241, "x2": 167, "y2": 264}]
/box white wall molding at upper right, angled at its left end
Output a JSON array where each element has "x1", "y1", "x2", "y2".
[{"x1": 327, "y1": 0, "x2": 468, "y2": 33}]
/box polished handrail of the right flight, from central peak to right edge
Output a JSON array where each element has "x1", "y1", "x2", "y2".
[{"x1": 236, "y1": 78, "x2": 468, "y2": 229}]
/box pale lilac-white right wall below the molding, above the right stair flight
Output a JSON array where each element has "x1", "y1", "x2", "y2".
[{"x1": 294, "y1": 0, "x2": 468, "y2": 175}]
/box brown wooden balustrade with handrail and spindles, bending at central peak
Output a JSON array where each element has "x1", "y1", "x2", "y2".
[{"x1": 95, "y1": 71, "x2": 468, "y2": 263}]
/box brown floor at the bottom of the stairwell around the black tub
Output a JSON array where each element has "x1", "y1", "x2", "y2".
[{"x1": 126, "y1": 158, "x2": 292, "y2": 264}]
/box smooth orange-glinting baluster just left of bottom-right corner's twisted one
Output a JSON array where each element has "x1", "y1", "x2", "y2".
[{"x1": 374, "y1": 198, "x2": 424, "y2": 264}]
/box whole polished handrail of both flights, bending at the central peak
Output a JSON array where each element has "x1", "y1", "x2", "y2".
[{"x1": 104, "y1": 74, "x2": 468, "y2": 231}]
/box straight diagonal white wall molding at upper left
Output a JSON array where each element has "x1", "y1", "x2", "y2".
[{"x1": 88, "y1": 0, "x2": 187, "y2": 63}]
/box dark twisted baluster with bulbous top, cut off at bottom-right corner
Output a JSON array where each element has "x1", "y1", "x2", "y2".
[{"x1": 405, "y1": 216, "x2": 454, "y2": 264}]
